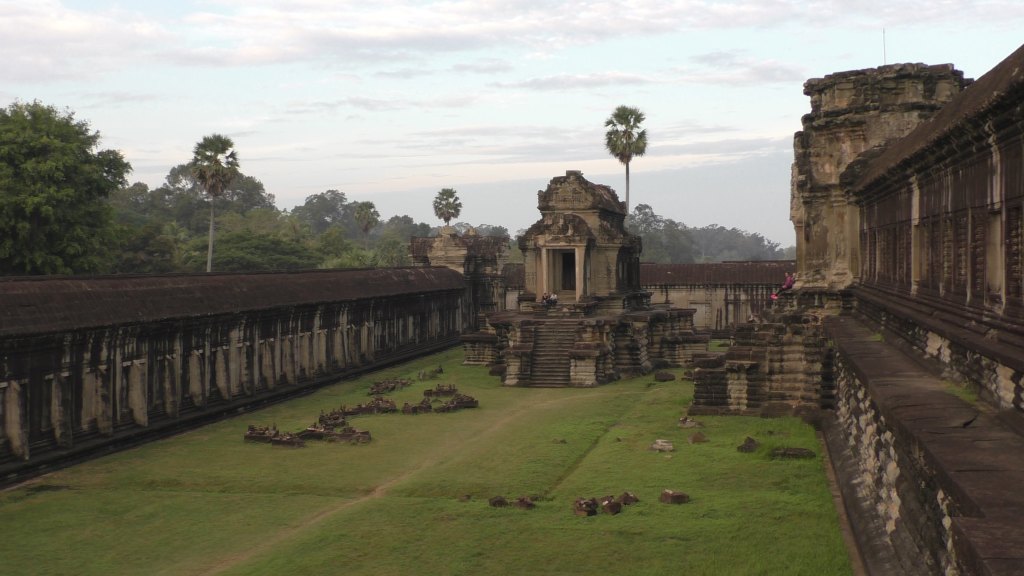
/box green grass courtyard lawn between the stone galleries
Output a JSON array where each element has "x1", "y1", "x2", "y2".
[{"x1": 0, "y1": 351, "x2": 850, "y2": 576}]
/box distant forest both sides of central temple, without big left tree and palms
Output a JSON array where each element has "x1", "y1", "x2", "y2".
[{"x1": 108, "y1": 182, "x2": 793, "y2": 273}]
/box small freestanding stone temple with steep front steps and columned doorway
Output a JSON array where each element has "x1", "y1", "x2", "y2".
[{"x1": 430, "y1": 170, "x2": 708, "y2": 386}]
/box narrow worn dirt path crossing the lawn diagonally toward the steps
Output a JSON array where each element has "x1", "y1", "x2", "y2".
[{"x1": 195, "y1": 390, "x2": 622, "y2": 576}]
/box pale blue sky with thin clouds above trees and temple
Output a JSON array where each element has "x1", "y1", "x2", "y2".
[{"x1": 0, "y1": 0, "x2": 1024, "y2": 247}]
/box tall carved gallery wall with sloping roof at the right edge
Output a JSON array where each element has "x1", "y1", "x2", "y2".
[{"x1": 844, "y1": 44, "x2": 1024, "y2": 410}]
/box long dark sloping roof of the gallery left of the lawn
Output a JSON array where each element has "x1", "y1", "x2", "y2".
[{"x1": 0, "y1": 268, "x2": 465, "y2": 335}]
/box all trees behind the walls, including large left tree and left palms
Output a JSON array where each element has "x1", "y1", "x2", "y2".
[{"x1": 0, "y1": 102, "x2": 792, "y2": 276}]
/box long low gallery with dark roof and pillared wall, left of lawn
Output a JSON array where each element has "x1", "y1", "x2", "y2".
[{"x1": 0, "y1": 269, "x2": 470, "y2": 480}]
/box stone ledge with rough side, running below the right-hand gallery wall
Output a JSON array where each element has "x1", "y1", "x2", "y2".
[{"x1": 825, "y1": 316, "x2": 1024, "y2": 575}]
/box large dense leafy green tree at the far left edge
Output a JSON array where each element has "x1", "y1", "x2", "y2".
[{"x1": 0, "y1": 101, "x2": 131, "y2": 275}]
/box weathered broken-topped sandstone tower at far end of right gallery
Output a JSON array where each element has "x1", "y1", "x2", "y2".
[{"x1": 790, "y1": 64, "x2": 964, "y2": 289}]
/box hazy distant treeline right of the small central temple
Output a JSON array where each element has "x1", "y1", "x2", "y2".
[{"x1": 627, "y1": 204, "x2": 796, "y2": 263}]
